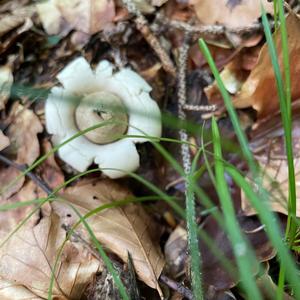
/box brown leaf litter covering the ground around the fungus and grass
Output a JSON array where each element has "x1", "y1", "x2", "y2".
[{"x1": 0, "y1": 0, "x2": 300, "y2": 299}]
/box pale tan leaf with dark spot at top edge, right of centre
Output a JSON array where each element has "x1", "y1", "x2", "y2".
[{"x1": 189, "y1": 0, "x2": 273, "y2": 28}]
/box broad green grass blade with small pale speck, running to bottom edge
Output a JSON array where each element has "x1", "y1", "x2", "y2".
[{"x1": 212, "y1": 118, "x2": 262, "y2": 300}]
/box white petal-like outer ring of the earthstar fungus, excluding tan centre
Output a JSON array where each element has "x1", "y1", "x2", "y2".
[{"x1": 45, "y1": 57, "x2": 161, "y2": 178}]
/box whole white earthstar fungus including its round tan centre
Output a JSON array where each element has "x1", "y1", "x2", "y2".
[{"x1": 45, "y1": 57, "x2": 161, "y2": 178}]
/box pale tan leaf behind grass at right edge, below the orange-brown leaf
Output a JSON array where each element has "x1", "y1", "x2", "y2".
[{"x1": 242, "y1": 116, "x2": 300, "y2": 217}]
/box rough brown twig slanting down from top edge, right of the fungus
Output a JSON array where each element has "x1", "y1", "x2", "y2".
[{"x1": 123, "y1": 0, "x2": 176, "y2": 77}]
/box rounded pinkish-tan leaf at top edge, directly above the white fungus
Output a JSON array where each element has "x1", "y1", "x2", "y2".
[{"x1": 53, "y1": 0, "x2": 115, "y2": 34}]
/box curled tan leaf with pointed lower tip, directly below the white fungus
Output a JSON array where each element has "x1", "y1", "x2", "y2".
[{"x1": 53, "y1": 180, "x2": 164, "y2": 292}]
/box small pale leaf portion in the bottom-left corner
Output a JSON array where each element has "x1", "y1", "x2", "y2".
[{"x1": 0, "y1": 278, "x2": 42, "y2": 300}]
